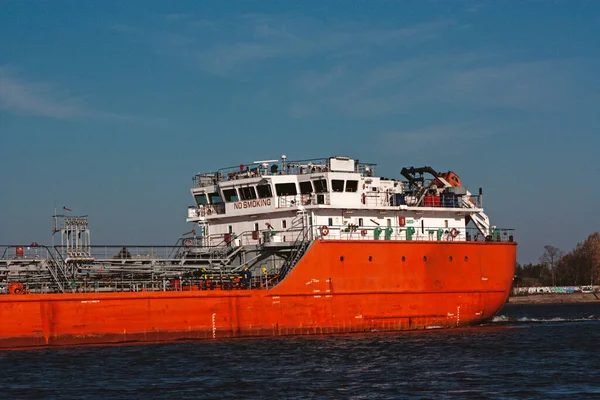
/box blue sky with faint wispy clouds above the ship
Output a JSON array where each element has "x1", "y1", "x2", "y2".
[{"x1": 0, "y1": 1, "x2": 600, "y2": 262}]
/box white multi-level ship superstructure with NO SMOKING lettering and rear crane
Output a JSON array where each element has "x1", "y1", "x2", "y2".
[{"x1": 187, "y1": 156, "x2": 494, "y2": 246}]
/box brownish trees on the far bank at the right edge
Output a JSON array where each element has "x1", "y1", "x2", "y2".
[{"x1": 514, "y1": 232, "x2": 600, "y2": 286}]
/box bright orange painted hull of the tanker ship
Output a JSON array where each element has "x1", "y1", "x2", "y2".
[{"x1": 0, "y1": 240, "x2": 516, "y2": 348}]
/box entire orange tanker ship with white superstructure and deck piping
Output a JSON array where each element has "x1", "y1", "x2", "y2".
[{"x1": 0, "y1": 156, "x2": 517, "y2": 349}]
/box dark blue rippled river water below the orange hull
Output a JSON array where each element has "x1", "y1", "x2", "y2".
[{"x1": 0, "y1": 304, "x2": 600, "y2": 399}]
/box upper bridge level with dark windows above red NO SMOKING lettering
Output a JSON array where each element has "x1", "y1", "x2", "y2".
[{"x1": 188, "y1": 156, "x2": 403, "y2": 222}]
